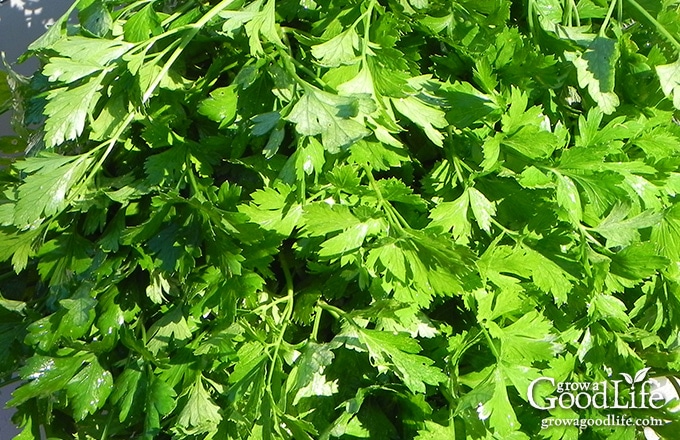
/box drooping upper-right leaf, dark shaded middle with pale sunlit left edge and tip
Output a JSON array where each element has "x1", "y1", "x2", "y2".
[{"x1": 572, "y1": 37, "x2": 620, "y2": 115}]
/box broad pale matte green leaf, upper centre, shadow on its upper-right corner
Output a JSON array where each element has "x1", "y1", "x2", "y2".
[{"x1": 287, "y1": 87, "x2": 371, "y2": 153}]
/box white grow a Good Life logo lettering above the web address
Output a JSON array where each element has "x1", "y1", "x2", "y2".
[{"x1": 527, "y1": 368, "x2": 666, "y2": 410}]
